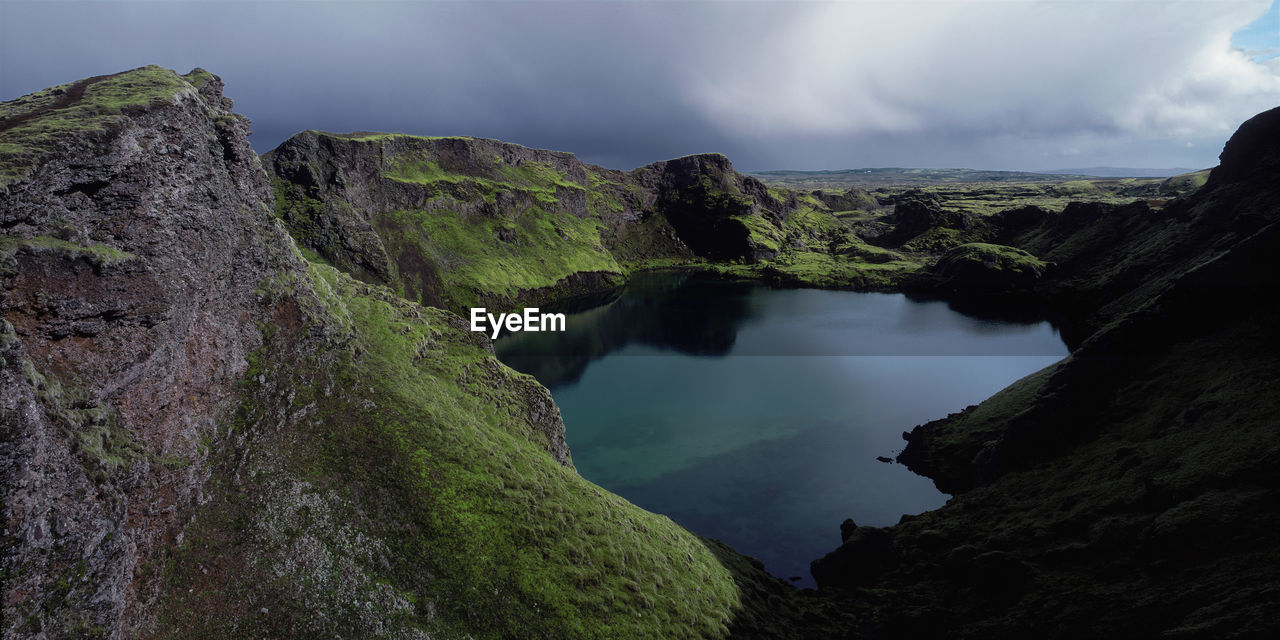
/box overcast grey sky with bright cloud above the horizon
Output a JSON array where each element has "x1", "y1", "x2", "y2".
[{"x1": 0, "y1": 0, "x2": 1280, "y2": 170}]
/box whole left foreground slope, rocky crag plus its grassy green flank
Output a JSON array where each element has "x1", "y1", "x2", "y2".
[{"x1": 0, "y1": 67, "x2": 798, "y2": 637}]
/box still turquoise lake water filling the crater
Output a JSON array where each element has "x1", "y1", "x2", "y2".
[{"x1": 495, "y1": 274, "x2": 1066, "y2": 586}]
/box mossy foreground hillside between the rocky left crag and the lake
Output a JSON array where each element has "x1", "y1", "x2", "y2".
[{"x1": 158, "y1": 265, "x2": 740, "y2": 637}]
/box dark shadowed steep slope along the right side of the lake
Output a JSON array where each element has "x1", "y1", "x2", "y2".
[{"x1": 813, "y1": 104, "x2": 1280, "y2": 637}]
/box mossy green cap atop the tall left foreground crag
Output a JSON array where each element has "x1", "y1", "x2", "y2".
[{"x1": 0, "y1": 65, "x2": 197, "y2": 187}]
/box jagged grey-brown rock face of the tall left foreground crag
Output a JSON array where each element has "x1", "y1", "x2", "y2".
[{"x1": 0, "y1": 68, "x2": 293, "y2": 637}]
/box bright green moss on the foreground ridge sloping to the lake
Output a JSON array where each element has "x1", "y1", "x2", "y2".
[{"x1": 319, "y1": 264, "x2": 736, "y2": 637}]
